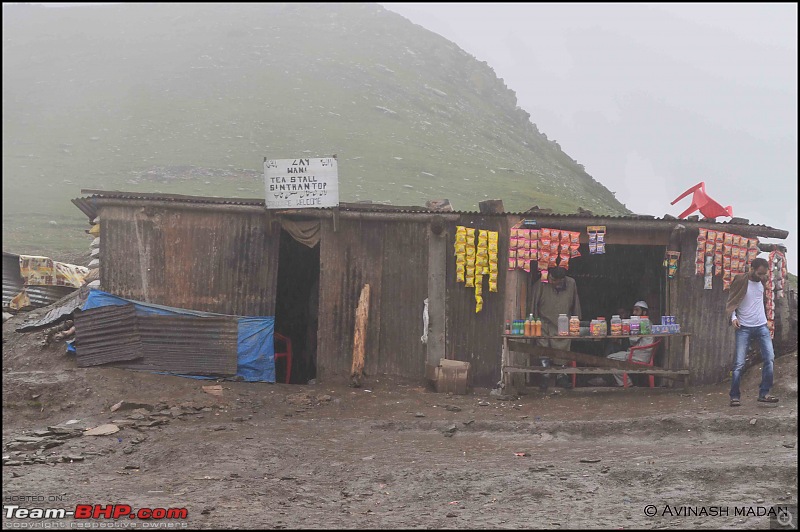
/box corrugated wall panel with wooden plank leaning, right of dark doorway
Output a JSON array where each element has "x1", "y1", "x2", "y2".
[{"x1": 317, "y1": 220, "x2": 428, "y2": 379}]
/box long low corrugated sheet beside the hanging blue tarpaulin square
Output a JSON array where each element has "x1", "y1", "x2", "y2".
[{"x1": 134, "y1": 316, "x2": 239, "y2": 376}]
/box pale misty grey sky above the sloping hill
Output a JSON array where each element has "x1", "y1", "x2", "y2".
[{"x1": 381, "y1": 3, "x2": 798, "y2": 274}]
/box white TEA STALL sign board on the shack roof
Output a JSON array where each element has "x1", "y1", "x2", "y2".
[{"x1": 264, "y1": 157, "x2": 339, "y2": 209}]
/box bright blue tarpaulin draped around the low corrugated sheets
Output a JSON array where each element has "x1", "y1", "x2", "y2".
[{"x1": 78, "y1": 289, "x2": 275, "y2": 382}]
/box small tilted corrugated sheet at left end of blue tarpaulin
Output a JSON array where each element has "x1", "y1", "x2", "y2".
[{"x1": 75, "y1": 305, "x2": 144, "y2": 367}]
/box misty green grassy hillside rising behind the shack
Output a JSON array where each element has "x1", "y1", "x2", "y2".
[{"x1": 3, "y1": 4, "x2": 629, "y2": 253}]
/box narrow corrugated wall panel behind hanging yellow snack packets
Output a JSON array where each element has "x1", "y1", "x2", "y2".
[{"x1": 446, "y1": 214, "x2": 509, "y2": 387}]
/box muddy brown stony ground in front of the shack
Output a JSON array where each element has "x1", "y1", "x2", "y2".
[{"x1": 2, "y1": 316, "x2": 797, "y2": 529}]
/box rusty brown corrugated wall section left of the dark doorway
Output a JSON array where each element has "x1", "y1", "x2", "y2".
[{"x1": 99, "y1": 204, "x2": 280, "y2": 316}]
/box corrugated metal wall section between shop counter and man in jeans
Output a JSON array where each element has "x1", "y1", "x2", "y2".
[{"x1": 668, "y1": 231, "x2": 735, "y2": 384}]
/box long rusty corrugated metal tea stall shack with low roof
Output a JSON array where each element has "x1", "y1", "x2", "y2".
[{"x1": 73, "y1": 190, "x2": 788, "y2": 387}]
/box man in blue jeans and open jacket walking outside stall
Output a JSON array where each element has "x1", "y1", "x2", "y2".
[{"x1": 725, "y1": 258, "x2": 778, "y2": 406}]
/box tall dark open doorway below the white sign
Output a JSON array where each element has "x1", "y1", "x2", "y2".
[{"x1": 275, "y1": 230, "x2": 320, "y2": 384}]
